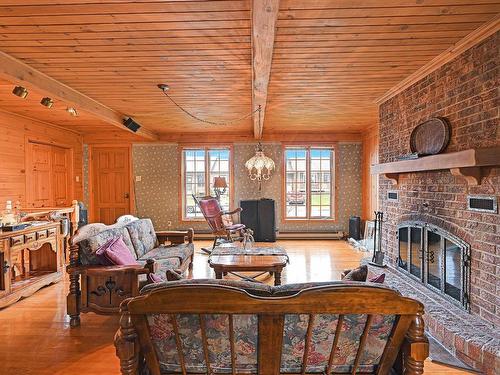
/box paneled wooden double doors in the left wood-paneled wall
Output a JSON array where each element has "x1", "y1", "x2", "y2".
[{"x1": 26, "y1": 142, "x2": 71, "y2": 207}]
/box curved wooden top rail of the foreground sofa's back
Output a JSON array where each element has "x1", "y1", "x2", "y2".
[{"x1": 128, "y1": 283, "x2": 423, "y2": 315}]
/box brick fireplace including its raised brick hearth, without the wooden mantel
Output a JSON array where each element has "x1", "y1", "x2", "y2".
[{"x1": 379, "y1": 32, "x2": 500, "y2": 373}]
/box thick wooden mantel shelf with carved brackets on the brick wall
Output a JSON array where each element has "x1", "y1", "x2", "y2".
[{"x1": 371, "y1": 147, "x2": 500, "y2": 185}]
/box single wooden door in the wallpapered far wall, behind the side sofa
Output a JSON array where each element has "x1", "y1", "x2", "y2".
[{"x1": 91, "y1": 147, "x2": 131, "y2": 224}]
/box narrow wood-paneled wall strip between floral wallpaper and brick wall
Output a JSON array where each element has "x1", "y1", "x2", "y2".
[{"x1": 362, "y1": 126, "x2": 379, "y2": 220}]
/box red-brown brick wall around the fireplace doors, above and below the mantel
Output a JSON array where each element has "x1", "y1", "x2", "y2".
[{"x1": 379, "y1": 32, "x2": 500, "y2": 327}]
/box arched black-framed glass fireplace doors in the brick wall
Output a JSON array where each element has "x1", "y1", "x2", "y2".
[{"x1": 398, "y1": 222, "x2": 470, "y2": 309}]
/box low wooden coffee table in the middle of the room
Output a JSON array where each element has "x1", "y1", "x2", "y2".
[{"x1": 208, "y1": 244, "x2": 288, "y2": 286}]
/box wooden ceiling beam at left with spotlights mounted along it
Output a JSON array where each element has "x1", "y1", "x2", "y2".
[{"x1": 0, "y1": 51, "x2": 158, "y2": 140}]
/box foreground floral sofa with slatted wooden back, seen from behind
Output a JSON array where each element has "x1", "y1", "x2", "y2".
[{"x1": 115, "y1": 280, "x2": 428, "y2": 375}]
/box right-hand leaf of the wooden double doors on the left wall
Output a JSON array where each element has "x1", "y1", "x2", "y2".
[{"x1": 52, "y1": 146, "x2": 71, "y2": 207}]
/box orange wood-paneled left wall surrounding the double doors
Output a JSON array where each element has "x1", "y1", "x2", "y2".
[{"x1": 0, "y1": 111, "x2": 83, "y2": 208}]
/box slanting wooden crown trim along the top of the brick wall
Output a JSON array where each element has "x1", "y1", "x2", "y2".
[{"x1": 375, "y1": 14, "x2": 500, "y2": 105}]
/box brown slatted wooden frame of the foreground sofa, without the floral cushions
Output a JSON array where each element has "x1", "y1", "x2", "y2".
[{"x1": 115, "y1": 284, "x2": 429, "y2": 375}]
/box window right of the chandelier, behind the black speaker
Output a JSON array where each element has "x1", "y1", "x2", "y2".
[{"x1": 283, "y1": 146, "x2": 335, "y2": 220}]
